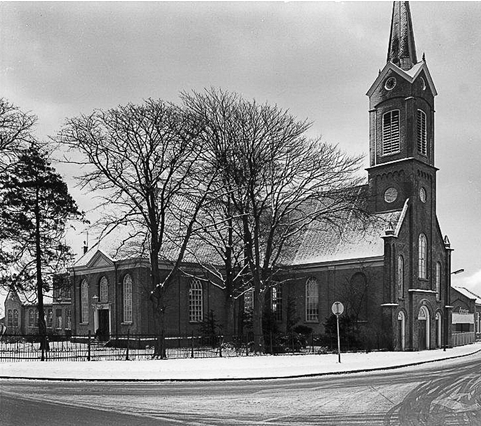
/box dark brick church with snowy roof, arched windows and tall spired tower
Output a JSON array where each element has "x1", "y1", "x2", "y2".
[{"x1": 5, "y1": 2, "x2": 460, "y2": 351}]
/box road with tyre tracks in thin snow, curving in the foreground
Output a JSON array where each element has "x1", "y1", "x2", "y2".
[{"x1": 0, "y1": 354, "x2": 481, "y2": 426}]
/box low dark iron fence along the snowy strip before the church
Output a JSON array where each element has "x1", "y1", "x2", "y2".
[{"x1": 0, "y1": 333, "x2": 366, "y2": 362}]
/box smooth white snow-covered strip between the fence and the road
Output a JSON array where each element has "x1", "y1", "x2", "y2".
[{"x1": 0, "y1": 343, "x2": 481, "y2": 380}]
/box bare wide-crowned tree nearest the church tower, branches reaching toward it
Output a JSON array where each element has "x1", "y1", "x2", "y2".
[{"x1": 182, "y1": 89, "x2": 362, "y2": 351}]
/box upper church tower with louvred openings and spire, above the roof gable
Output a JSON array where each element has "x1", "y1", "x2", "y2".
[{"x1": 367, "y1": 1, "x2": 437, "y2": 213}]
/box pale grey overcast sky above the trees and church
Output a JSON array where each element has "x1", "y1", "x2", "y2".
[{"x1": 0, "y1": 1, "x2": 481, "y2": 300}]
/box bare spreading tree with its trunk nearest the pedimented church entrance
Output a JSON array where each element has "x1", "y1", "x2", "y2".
[{"x1": 58, "y1": 99, "x2": 215, "y2": 358}]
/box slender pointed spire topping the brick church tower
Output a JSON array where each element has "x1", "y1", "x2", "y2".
[{"x1": 387, "y1": 1, "x2": 417, "y2": 71}]
